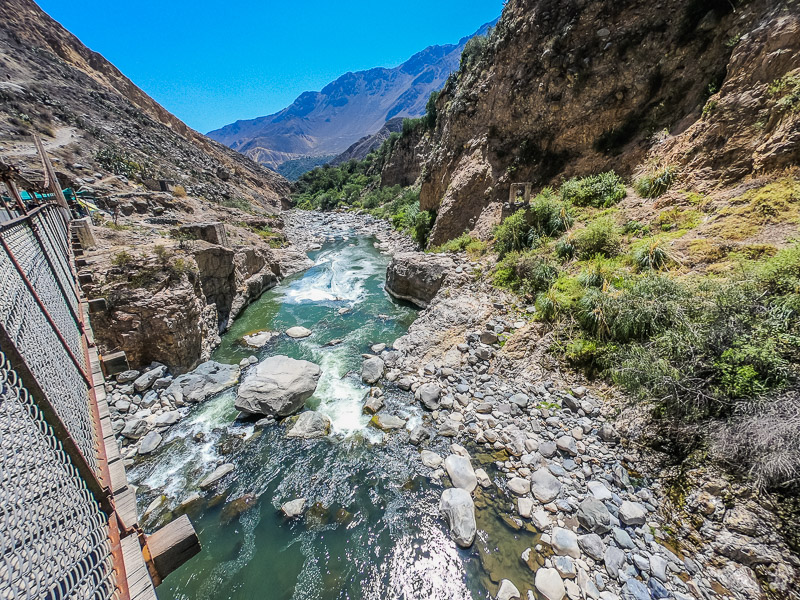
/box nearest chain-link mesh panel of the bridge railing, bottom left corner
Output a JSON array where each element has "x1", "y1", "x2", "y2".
[{"x1": 0, "y1": 352, "x2": 119, "y2": 600}]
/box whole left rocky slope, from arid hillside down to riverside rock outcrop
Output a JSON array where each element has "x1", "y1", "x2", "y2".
[{"x1": 0, "y1": 0, "x2": 307, "y2": 373}]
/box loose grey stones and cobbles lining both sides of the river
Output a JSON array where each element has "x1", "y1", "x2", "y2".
[{"x1": 119, "y1": 212, "x2": 798, "y2": 600}]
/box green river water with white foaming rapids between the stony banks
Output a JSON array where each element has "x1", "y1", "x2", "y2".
[{"x1": 130, "y1": 232, "x2": 532, "y2": 600}]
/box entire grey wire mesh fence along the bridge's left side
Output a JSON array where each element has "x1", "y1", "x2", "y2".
[{"x1": 0, "y1": 206, "x2": 127, "y2": 600}]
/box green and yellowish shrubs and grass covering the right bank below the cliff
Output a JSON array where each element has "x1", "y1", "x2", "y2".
[{"x1": 476, "y1": 175, "x2": 800, "y2": 487}]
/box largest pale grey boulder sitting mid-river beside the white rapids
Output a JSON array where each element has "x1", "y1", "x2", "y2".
[{"x1": 235, "y1": 356, "x2": 321, "y2": 417}]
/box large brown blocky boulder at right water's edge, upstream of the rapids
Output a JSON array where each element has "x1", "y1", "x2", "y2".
[{"x1": 386, "y1": 252, "x2": 455, "y2": 308}]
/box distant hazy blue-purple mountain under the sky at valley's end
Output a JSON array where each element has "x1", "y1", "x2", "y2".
[{"x1": 208, "y1": 22, "x2": 494, "y2": 169}]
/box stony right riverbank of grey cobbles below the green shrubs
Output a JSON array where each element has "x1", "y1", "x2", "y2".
[{"x1": 388, "y1": 241, "x2": 800, "y2": 600}]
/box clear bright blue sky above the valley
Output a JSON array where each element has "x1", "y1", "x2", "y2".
[{"x1": 37, "y1": 0, "x2": 503, "y2": 133}]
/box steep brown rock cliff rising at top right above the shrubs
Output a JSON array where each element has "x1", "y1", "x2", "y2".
[{"x1": 420, "y1": 0, "x2": 800, "y2": 244}]
